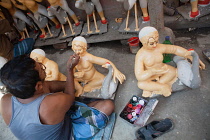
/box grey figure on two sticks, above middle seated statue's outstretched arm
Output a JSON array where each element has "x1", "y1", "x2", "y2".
[{"x1": 75, "y1": 0, "x2": 107, "y2": 33}]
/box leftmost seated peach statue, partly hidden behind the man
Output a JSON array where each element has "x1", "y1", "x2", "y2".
[{"x1": 30, "y1": 49, "x2": 66, "y2": 81}]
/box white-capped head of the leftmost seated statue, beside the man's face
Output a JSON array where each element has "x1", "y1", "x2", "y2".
[{"x1": 30, "y1": 49, "x2": 46, "y2": 63}]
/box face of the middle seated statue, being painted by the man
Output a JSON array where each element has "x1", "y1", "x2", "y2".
[{"x1": 72, "y1": 41, "x2": 86, "y2": 55}]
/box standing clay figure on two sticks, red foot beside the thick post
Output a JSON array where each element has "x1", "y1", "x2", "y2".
[{"x1": 118, "y1": 0, "x2": 150, "y2": 31}]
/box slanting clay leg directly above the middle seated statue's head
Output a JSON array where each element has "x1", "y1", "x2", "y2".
[{"x1": 61, "y1": 0, "x2": 79, "y2": 25}]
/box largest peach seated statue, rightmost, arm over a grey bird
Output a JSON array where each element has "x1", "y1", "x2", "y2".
[{"x1": 135, "y1": 26, "x2": 205, "y2": 97}]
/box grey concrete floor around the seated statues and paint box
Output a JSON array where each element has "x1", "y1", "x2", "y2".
[{"x1": 0, "y1": 28, "x2": 210, "y2": 140}]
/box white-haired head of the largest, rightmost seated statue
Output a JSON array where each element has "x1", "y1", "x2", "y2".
[{"x1": 139, "y1": 26, "x2": 159, "y2": 49}]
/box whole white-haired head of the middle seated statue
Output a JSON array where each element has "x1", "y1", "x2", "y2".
[{"x1": 72, "y1": 36, "x2": 87, "y2": 55}]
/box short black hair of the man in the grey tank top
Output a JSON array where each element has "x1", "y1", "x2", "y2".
[{"x1": 0, "y1": 55, "x2": 41, "y2": 99}]
